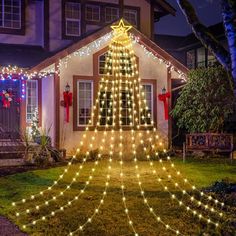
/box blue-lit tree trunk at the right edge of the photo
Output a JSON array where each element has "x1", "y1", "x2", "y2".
[{"x1": 221, "y1": 0, "x2": 236, "y2": 84}]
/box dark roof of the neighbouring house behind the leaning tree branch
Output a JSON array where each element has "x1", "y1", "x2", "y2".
[{"x1": 155, "y1": 22, "x2": 225, "y2": 51}]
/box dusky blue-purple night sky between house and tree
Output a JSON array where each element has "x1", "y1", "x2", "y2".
[{"x1": 155, "y1": 0, "x2": 222, "y2": 35}]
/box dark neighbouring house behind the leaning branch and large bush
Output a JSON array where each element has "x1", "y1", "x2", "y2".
[{"x1": 155, "y1": 22, "x2": 236, "y2": 145}]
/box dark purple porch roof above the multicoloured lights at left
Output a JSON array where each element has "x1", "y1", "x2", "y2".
[{"x1": 0, "y1": 44, "x2": 51, "y2": 68}]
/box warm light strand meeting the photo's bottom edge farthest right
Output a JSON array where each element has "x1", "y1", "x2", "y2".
[{"x1": 127, "y1": 79, "x2": 183, "y2": 235}]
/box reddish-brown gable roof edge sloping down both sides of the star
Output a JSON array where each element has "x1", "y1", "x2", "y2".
[{"x1": 32, "y1": 20, "x2": 188, "y2": 73}]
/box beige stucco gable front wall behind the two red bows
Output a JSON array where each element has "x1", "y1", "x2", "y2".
[{"x1": 57, "y1": 37, "x2": 168, "y2": 154}]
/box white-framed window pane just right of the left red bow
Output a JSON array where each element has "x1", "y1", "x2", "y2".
[{"x1": 77, "y1": 80, "x2": 93, "y2": 126}]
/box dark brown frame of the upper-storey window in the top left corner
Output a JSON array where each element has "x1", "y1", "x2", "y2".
[{"x1": 0, "y1": 0, "x2": 26, "y2": 35}]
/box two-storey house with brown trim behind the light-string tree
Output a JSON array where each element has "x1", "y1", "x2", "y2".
[{"x1": 0, "y1": 0, "x2": 187, "y2": 154}]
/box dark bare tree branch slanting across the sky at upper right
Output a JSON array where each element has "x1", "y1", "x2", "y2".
[{"x1": 176, "y1": 0, "x2": 231, "y2": 71}]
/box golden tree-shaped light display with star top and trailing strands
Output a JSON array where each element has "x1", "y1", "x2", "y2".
[{"x1": 12, "y1": 20, "x2": 227, "y2": 236}]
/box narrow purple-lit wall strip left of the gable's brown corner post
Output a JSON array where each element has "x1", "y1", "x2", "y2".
[{"x1": 42, "y1": 76, "x2": 55, "y2": 145}]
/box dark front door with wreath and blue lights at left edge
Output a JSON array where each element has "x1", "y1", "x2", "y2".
[{"x1": 0, "y1": 79, "x2": 20, "y2": 139}]
